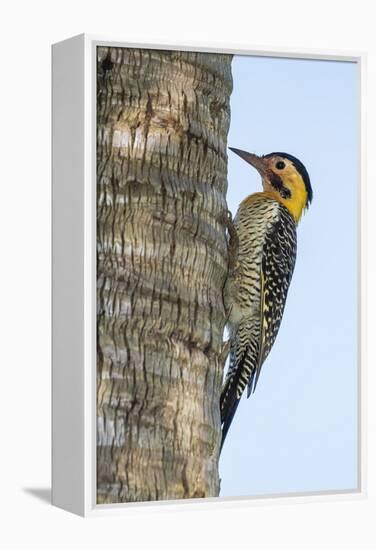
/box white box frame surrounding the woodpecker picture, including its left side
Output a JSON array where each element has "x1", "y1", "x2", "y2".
[{"x1": 52, "y1": 34, "x2": 366, "y2": 516}]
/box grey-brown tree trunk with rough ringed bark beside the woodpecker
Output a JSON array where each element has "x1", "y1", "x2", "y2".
[{"x1": 97, "y1": 47, "x2": 232, "y2": 503}]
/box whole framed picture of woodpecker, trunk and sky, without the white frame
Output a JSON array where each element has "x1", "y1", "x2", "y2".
[{"x1": 96, "y1": 46, "x2": 359, "y2": 504}]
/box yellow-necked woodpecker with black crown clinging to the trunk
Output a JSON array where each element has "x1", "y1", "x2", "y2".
[{"x1": 220, "y1": 147, "x2": 312, "y2": 449}]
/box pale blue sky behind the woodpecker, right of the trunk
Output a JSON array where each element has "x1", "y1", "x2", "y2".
[{"x1": 220, "y1": 56, "x2": 359, "y2": 496}]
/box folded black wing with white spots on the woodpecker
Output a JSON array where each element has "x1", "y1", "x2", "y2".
[{"x1": 248, "y1": 205, "x2": 296, "y2": 395}]
